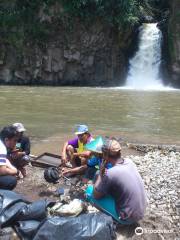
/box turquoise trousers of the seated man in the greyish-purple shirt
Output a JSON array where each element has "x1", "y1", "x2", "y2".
[{"x1": 85, "y1": 185, "x2": 134, "y2": 225}]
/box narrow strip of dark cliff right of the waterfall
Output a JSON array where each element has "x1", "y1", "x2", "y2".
[{"x1": 168, "y1": 0, "x2": 180, "y2": 87}]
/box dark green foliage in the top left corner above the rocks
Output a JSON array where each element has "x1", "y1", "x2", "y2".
[{"x1": 0, "y1": 0, "x2": 52, "y2": 48}]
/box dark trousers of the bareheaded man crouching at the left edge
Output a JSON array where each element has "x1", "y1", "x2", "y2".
[{"x1": 0, "y1": 175, "x2": 17, "y2": 190}]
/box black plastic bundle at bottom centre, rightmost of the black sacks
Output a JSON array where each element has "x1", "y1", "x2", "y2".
[{"x1": 33, "y1": 213, "x2": 116, "y2": 240}]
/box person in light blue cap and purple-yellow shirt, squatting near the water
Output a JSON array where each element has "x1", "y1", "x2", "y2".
[{"x1": 62, "y1": 125, "x2": 93, "y2": 175}]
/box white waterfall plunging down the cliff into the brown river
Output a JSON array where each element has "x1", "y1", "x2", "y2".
[{"x1": 126, "y1": 23, "x2": 163, "y2": 89}]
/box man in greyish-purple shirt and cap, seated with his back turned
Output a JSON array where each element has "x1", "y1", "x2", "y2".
[{"x1": 86, "y1": 139, "x2": 146, "y2": 224}]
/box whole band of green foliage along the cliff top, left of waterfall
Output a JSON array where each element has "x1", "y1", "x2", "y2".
[{"x1": 0, "y1": 0, "x2": 146, "y2": 45}]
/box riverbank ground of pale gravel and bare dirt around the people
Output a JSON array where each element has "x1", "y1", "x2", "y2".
[{"x1": 8, "y1": 146, "x2": 177, "y2": 240}]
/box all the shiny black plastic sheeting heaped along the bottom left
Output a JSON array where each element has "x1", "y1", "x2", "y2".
[{"x1": 0, "y1": 190, "x2": 115, "y2": 240}]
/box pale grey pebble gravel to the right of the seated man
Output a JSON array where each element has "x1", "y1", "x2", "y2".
[{"x1": 128, "y1": 150, "x2": 180, "y2": 233}]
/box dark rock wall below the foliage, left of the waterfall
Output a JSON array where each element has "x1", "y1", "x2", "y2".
[{"x1": 0, "y1": 22, "x2": 133, "y2": 86}]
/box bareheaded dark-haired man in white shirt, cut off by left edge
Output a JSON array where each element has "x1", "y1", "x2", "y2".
[{"x1": 0, "y1": 126, "x2": 18, "y2": 190}]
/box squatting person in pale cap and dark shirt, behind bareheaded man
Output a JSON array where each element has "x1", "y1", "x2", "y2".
[{"x1": 9, "y1": 123, "x2": 30, "y2": 178}]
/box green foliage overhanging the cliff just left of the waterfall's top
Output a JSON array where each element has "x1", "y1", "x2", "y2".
[{"x1": 63, "y1": 0, "x2": 141, "y2": 27}]
